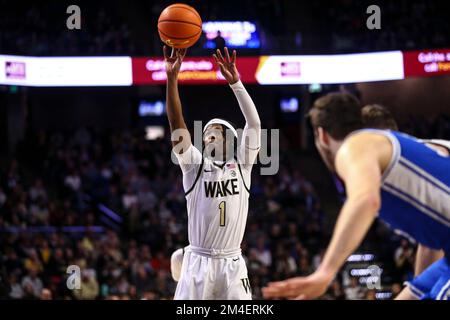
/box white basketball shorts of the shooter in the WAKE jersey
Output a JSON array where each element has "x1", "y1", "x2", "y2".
[{"x1": 174, "y1": 249, "x2": 252, "y2": 300}]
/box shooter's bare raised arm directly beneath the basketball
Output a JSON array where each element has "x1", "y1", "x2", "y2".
[{"x1": 163, "y1": 46, "x2": 192, "y2": 153}]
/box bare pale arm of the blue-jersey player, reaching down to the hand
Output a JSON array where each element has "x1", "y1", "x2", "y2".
[{"x1": 263, "y1": 136, "x2": 381, "y2": 299}]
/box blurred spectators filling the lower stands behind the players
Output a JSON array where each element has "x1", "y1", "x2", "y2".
[{"x1": 0, "y1": 110, "x2": 450, "y2": 299}]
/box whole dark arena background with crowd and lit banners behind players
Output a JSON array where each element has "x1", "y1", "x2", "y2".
[{"x1": 0, "y1": 0, "x2": 450, "y2": 300}]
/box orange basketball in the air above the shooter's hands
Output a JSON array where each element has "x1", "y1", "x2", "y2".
[{"x1": 158, "y1": 3, "x2": 202, "y2": 49}]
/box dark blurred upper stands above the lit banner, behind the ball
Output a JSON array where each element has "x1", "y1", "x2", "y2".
[{"x1": 0, "y1": 0, "x2": 450, "y2": 55}]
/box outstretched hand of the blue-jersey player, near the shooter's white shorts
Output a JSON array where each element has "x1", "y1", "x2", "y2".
[{"x1": 262, "y1": 272, "x2": 332, "y2": 300}]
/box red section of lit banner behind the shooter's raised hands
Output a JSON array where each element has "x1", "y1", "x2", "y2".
[{"x1": 132, "y1": 57, "x2": 260, "y2": 85}]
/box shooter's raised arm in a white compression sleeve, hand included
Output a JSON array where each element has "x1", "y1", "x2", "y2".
[{"x1": 213, "y1": 47, "x2": 261, "y2": 165}]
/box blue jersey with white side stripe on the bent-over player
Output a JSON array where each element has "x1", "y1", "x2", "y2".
[{"x1": 354, "y1": 129, "x2": 450, "y2": 257}]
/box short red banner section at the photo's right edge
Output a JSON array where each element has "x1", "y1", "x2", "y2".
[{"x1": 403, "y1": 49, "x2": 450, "y2": 78}]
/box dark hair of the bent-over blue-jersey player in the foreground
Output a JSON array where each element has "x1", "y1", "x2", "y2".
[{"x1": 308, "y1": 92, "x2": 363, "y2": 140}]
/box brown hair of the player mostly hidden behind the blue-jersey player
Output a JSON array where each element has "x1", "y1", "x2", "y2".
[{"x1": 361, "y1": 104, "x2": 398, "y2": 131}]
